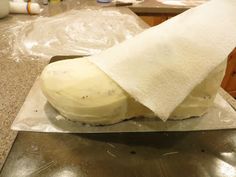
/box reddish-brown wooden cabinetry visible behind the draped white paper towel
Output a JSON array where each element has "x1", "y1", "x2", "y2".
[{"x1": 138, "y1": 14, "x2": 236, "y2": 98}]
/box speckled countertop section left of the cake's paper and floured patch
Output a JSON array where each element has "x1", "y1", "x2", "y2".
[{"x1": 0, "y1": 16, "x2": 46, "y2": 168}]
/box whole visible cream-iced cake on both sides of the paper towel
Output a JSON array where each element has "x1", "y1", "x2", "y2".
[{"x1": 40, "y1": 58, "x2": 224, "y2": 124}]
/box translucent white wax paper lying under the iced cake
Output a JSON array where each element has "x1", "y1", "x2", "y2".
[{"x1": 11, "y1": 76, "x2": 236, "y2": 133}]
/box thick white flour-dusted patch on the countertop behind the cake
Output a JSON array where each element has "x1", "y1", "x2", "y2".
[{"x1": 14, "y1": 8, "x2": 143, "y2": 58}]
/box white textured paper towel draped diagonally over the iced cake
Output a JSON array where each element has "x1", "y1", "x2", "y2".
[{"x1": 90, "y1": 0, "x2": 236, "y2": 120}]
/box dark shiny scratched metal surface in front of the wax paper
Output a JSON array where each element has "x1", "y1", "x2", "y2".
[{"x1": 0, "y1": 130, "x2": 236, "y2": 177}]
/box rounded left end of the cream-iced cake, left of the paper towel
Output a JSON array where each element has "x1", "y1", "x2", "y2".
[{"x1": 40, "y1": 58, "x2": 151, "y2": 124}]
